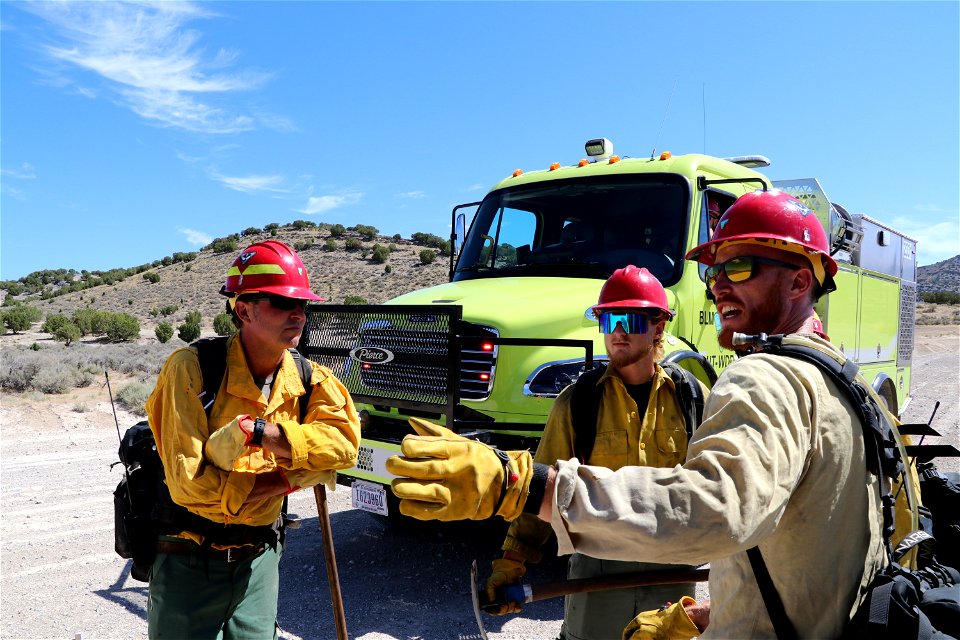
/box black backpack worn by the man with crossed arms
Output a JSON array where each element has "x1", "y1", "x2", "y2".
[{"x1": 113, "y1": 337, "x2": 313, "y2": 582}]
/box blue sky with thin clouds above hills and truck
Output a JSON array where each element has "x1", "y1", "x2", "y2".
[{"x1": 0, "y1": 1, "x2": 960, "y2": 279}]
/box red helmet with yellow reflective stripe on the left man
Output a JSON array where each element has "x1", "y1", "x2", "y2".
[{"x1": 220, "y1": 240, "x2": 323, "y2": 302}]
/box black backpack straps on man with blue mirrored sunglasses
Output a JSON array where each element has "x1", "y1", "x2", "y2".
[{"x1": 570, "y1": 362, "x2": 703, "y2": 464}]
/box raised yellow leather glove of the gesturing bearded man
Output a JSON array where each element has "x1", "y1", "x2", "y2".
[{"x1": 386, "y1": 418, "x2": 533, "y2": 520}]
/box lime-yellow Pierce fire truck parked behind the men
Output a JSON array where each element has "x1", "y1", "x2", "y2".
[{"x1": 300, "y1": 138, "x2": 917, "y2": 516}]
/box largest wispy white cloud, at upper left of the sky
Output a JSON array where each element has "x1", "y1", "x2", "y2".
[{"x1": 21, "y1": 2, "x2": 268, "y2": 133}]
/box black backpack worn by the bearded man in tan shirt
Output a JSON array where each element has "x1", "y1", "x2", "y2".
[{"x1": 732, "y1": 334, "x2": 960, "y2": 640}]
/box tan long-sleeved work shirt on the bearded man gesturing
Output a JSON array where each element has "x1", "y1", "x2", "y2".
[{"x1": 553, "y1": 334, "x2": 885, "y2": 638}]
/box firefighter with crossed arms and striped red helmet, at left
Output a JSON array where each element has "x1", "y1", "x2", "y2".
[{"x1": 146, "y1": 240, "x2": 360, "y2": 639}]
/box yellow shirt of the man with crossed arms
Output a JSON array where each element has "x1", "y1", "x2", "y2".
[{"x1": 146, "y1": 336, "x2": 360, "y2": 541}]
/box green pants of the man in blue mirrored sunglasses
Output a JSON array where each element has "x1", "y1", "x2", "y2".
[{"x1": 560, "y1": 553, "x2": 696, "y2": 640}]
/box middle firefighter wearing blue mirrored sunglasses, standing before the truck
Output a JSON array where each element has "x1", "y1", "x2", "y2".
[{"x1": 485, "y1": 265, "x2": 705, "y2": 640}]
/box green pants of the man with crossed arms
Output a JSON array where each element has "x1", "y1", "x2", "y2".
[{"x1": 147, "y1": 545, "x2": 282, "y2": 640}]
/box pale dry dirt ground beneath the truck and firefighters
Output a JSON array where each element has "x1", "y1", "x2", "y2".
[{"x1": 0, "y1": 325, "x2": 960, "y2": 640}]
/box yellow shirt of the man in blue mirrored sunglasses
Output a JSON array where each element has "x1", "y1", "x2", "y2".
[{"x1": 503, "y1": 365, "x2": 706, "y2": 562}]
